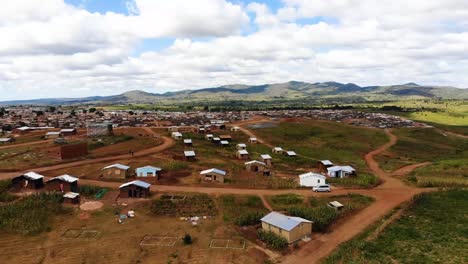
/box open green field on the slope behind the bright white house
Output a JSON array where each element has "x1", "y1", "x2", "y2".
[{"x1": 249, "y1": 120, "x2": 388, "y2": 173}]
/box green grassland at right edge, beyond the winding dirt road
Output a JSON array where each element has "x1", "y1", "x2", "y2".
[{"x1": 377, "y1": 128, "x2": 468, "y2": 187}]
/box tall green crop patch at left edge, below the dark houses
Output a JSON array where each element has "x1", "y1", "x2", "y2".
[{"x1": 0, "y1": 193, "x2": 68, "y2": 235}]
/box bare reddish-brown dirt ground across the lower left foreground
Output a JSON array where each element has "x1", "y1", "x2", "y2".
[{"x1": 0, "y1": 193, "x2": 267, "y2": 264}]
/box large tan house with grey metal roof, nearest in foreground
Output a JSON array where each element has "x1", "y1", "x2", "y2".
[{"x1": 260, "y1": 212, "x2": 313, "y2": 243}]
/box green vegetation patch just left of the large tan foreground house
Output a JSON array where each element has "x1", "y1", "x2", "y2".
[{"x1": 218, "y1": 195, "x2": 267, "y2": 226}]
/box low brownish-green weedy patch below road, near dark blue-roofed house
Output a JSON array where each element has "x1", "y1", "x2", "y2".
[{"x1": 150, "y1": 194, "x2": 218, "y2": 217}]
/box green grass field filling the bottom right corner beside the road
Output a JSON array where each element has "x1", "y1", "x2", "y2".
[{"x1": 324, "y1": 190, "x2": 468, "y2": 264}]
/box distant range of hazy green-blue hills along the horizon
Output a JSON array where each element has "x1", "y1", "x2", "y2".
[{"x1": 0, "y1": 81, "x2": 468, "y2": 105}]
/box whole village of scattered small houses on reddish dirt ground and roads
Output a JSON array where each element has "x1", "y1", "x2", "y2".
[{"x1": 0, "y1": 107, "x2": 466, "y2": 263}]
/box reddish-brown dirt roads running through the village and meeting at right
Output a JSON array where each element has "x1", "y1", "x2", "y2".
[{"x1": 0, "y1": 120, "x2": 431, "y2": 263}]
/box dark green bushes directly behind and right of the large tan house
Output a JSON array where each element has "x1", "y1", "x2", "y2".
[{"x1": 288, "y1": 205, "x2": 338, "y2": 232}]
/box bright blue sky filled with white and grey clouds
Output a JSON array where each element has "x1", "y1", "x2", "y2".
[{"x1": 0, "y1": 0, "x2": 468, "y2": 101}]
